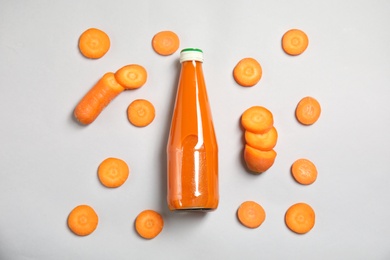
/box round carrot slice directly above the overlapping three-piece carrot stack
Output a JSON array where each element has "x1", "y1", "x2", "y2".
[{"x1": 233, "y1": 58, "x2": 263, "y2": 87}]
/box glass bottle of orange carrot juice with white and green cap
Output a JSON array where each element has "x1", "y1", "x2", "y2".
[{"x1": 167, "y1": 48, "x2": 219, "y2": 211}]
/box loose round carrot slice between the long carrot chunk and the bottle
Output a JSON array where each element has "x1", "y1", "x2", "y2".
[{"x1": 127, "y1": 99, "x2": 155, "y2": 127}]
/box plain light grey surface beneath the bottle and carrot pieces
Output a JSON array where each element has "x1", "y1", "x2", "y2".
[{"x1": 0, "y1": 0, "x2": 390, "y2": 259}]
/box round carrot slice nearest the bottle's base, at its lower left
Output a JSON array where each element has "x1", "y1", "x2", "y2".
[{"x1": 135, "y1": 209, "x2": 164, "y2": 239}]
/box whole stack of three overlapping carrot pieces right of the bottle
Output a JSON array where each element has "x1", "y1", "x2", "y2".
[{"x1": 241, "y1": 106, "x2": 278, "y2": 173}]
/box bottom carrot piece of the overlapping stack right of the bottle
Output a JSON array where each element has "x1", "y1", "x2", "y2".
[{"x1": 244, "y1": 144, "x2": 277, "y2": 173}]
